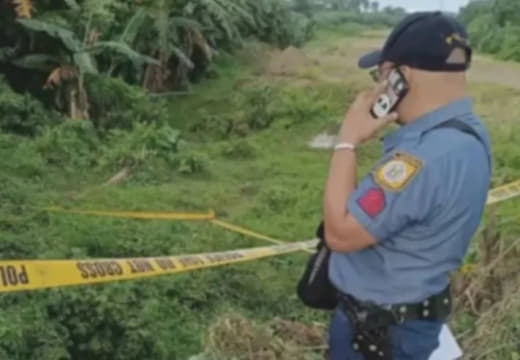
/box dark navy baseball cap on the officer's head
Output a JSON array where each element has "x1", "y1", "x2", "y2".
[{"x1": 359, "y1": 12, "x2": 472, "y2": 71}]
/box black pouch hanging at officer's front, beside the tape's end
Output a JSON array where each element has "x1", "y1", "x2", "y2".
[{"x1": 297, "y1": 222, "x2": 339, "y2": 310}]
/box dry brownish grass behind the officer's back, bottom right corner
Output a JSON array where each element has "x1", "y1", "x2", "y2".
[{"x1": 455, "y1": 210, "x2": 520, "y2": 360}]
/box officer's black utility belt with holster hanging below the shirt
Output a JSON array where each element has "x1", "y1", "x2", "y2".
[{"x1": 339, "y1": 287, "x2": 452, "y2": 360}]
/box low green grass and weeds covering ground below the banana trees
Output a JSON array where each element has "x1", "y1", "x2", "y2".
[{"x1": 0, "y1": 24, "x2": 520, "y2": 360}]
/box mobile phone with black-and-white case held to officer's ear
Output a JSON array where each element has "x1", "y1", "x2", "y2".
[{"x1": 370, "y1": 68, "x2": 409, "y2": 119}]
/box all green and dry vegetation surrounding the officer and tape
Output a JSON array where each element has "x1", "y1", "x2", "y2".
[{"x1": 0, "y1": 0, "x2": 520, "y2": 360}]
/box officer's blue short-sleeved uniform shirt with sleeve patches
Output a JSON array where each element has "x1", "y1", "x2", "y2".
[{"x1": 329, "y1": 99, "x2": 492, "y2": 305}]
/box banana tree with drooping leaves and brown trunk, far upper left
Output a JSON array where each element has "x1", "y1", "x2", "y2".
[{"x1": 12, "y1": 13, "x2": 158, "y2": 119}]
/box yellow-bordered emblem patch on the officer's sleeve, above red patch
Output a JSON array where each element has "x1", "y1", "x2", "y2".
[{"x1": 374, "y1": 153, "x2": 424, "y2": 191}]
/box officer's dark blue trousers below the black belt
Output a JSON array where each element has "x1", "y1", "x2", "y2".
[{"x1": 329, "y1": 309, "x2": 444, "y2": 360}]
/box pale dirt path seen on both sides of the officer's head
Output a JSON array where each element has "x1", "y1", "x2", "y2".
[{"x1": 268, "y1": 32, "x2": 520, "y2": 90}]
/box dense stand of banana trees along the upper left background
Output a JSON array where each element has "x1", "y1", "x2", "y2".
[{"x1": 0, "y1": 0, "x2": 312, "y2": 130}]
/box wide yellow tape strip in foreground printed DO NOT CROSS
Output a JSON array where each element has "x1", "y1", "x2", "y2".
[{"x1": 0, "y1": 240, "x2": 316, "y2": 293}]
